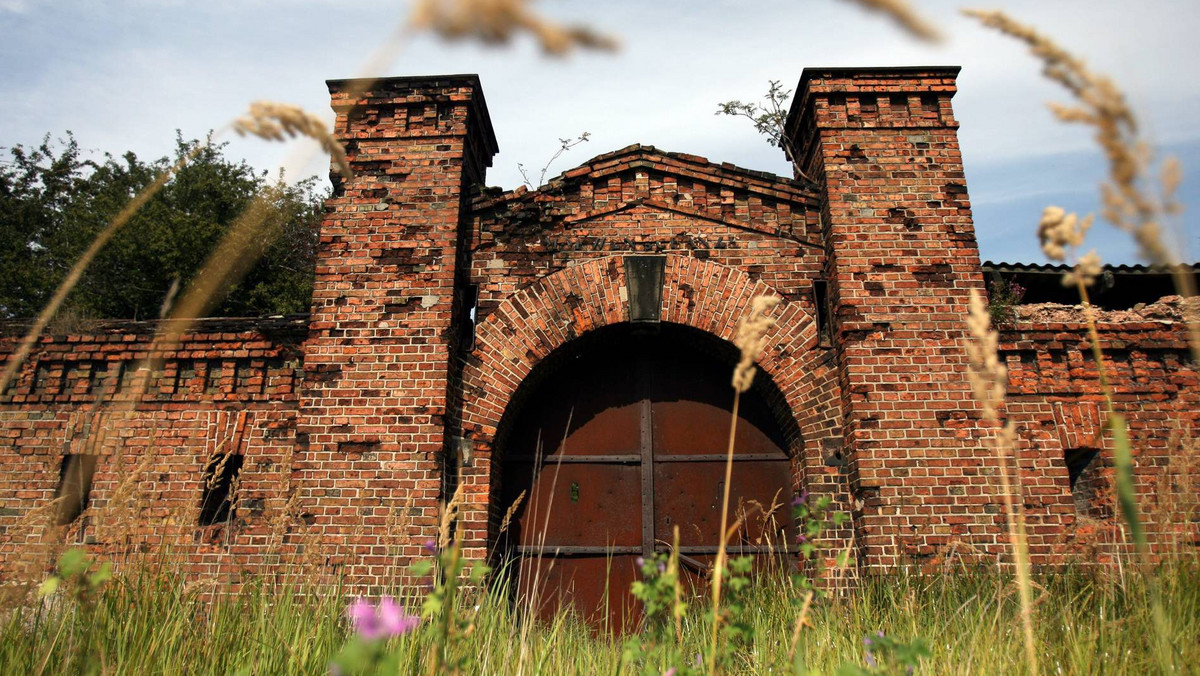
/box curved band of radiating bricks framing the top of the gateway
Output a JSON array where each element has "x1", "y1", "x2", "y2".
[{"x1": 461, "y1": 255, "x2": 823, "y2": 555}]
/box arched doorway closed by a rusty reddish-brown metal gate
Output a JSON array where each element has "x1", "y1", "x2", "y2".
[{"x1": 497, "y1": 323, "x2": 797, "y2": 627}]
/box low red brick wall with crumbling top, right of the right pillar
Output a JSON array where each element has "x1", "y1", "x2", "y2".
[{"x1": 1001, "y1": 298, "x2": 1200, "y2": 563}]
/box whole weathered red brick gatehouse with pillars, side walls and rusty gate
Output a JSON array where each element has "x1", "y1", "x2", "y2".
[{"x1": 0, "y1": 67, "x2": 1198, "y2": 619}]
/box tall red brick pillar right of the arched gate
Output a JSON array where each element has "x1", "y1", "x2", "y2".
[{"x1": 787, "y1": 67, "x2": 998, "y2": 569}]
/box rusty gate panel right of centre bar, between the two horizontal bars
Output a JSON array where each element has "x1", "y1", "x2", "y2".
[{"x1": 654, "y1": 459, "x2": 792, "y2": 548}]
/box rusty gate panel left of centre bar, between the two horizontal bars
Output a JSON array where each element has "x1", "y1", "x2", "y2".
[{"x1": 505, "y1": 462, "x2": 642, "y2": 546}]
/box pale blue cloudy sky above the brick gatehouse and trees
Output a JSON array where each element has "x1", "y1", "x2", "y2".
[{"x1": 0, "y1": 0, "x2": 1200, "y2": 263}]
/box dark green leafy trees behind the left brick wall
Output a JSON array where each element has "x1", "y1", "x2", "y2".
[{"x1": 0, "y1": 133, "x2": 325, "y2": 318}]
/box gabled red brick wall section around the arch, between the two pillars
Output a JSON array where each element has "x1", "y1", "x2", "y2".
[{"x1": 462, "y1": 145, "x2": 847, "y2": 561}]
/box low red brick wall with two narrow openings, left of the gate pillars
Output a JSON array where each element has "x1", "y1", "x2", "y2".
[{"x1": 0, "y1": 318, "x2": 307, "y2": 582}]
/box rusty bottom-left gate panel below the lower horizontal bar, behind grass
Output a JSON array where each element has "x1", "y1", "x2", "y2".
[{"x1": 516, "y1": 555, "x2": 641, "y2": 634}]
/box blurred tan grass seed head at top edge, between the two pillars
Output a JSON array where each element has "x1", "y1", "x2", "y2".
[{"x1": 409, "y1": 0, "x2": 617, "y2": 56}]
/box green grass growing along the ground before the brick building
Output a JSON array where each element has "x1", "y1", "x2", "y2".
[{"x1": 0, "y1": 561, "x2": 1200, "y2": 674}]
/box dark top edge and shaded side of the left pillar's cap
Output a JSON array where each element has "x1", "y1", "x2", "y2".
[{"x1": 325, "y1": 73, "x2": 499, "y2": 167}]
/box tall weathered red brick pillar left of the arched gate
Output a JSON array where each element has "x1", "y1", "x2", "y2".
[{"x1": 293, "y1": 76, "x2": 497, "y2": 585}]
